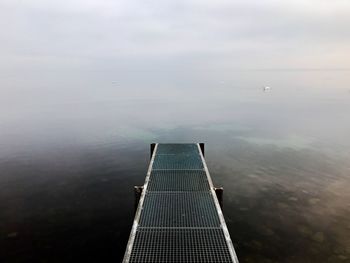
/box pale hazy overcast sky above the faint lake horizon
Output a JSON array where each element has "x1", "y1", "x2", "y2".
[{"x1": 0, "y1": 0, "x2": 350, "y2": 72}]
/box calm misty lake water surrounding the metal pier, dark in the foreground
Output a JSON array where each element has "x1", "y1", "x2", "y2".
[{"x1": 0, "y1": 70, "x2": 350, "y2": 263}]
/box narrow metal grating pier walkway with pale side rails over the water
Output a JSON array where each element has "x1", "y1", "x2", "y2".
[{"x1": 123, "y1": 143, "x2": 238, "y2": 263}]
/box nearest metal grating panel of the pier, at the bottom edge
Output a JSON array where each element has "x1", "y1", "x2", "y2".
[{"x1": 130, "y1": 228, "x2": 232, "y2": 263}]
